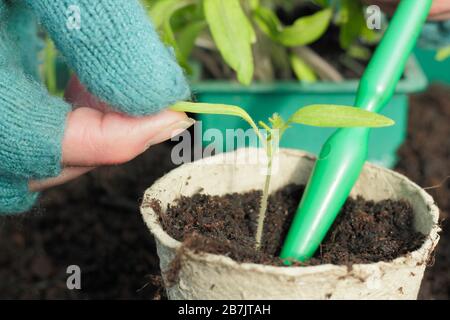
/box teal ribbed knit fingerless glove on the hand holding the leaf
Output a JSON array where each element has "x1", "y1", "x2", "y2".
[{"x1": 0, "y1": 0, "x2": 190, "y2": 214}]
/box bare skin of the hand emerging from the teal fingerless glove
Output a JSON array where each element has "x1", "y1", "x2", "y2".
[{"x1": 29, "y1": 76, "x2": 194, "y2": 192}]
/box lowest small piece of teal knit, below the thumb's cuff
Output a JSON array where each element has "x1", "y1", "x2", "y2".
[{"x1": 0, "y1": 176, "x2": 39, "y2": 216}]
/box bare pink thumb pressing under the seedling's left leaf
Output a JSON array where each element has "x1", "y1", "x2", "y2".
[{"x1": 63, "y1": 108, "x2": 194, "y2": 167}]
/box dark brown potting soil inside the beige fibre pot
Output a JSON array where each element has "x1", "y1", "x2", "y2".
[{"x1": 156, "y1": 185, "x2": 425, "y2": 266}]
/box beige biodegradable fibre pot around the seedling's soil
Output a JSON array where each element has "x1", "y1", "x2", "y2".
[{"x1": 141, "y1": 149, "x2": 440, "y2": 299}]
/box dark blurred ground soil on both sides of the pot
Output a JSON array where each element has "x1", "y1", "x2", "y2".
[{"x1": 0, "y1": 87, "x2": 450, "y2": 299}]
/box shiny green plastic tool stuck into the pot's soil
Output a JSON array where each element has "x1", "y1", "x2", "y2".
[{"x1": 281, "y1": 0, "x2": 432, "y2": 264}]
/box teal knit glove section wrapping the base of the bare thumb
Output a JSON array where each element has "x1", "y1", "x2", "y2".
[{"x1": 0, "y1": 66, "x2": 71, "y2": 179}]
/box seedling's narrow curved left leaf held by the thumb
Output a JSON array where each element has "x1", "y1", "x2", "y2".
[{"x1": 170, "y1": 101, "x2": 259, "y2": 133}]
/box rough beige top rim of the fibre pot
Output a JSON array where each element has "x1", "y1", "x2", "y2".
[{"x1": 141, "y1": 148, "x2": 441, "y2": 277}]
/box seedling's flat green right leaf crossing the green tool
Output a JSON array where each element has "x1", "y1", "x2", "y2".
[{"x1": 288, "y1": 105, "x2": 395, "y2": 128}]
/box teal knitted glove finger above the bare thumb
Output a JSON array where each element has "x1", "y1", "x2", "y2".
[{"x1": 26, "y1": 0, "x2": 190, "y2": 115}]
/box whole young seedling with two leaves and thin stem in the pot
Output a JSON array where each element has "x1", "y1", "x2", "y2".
[{"x1": 171, "y1": 102, "x2": 394, "y2": 249}]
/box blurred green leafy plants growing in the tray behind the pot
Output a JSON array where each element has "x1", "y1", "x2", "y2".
[{"x1": 146, "y1": 0, "x2": 379, "y2": 85}]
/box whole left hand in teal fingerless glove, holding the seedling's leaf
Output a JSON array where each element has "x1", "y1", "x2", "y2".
[{"x1": 0, "y1": 0, "x2": 192, "y2": 213}]
